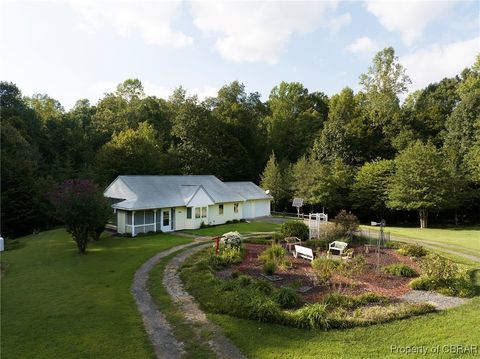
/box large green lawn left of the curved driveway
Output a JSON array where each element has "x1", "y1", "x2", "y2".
[{"x1": 1, "y1": 229, "x2": 190, "y2": 358}]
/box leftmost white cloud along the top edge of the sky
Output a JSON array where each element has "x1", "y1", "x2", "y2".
[{"x1": 67, "y1": 0, "x2": 193, "y2": 47}]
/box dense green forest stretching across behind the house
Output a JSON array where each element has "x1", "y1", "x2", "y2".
[{"x1": 0, "y1": 48, "x2": 480, "y2": 237}]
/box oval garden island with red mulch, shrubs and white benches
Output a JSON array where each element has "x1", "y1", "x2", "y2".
[{"x1": 182, "y1": 222, "x2": 475, "y2": 329}]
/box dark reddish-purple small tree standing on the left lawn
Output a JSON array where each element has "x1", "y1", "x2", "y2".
[{"x1": 50, "y1": 179, "x2": 112, "y2": 254}]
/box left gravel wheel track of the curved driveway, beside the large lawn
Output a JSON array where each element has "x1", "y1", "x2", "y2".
[{"x1": 132, "y1": 241, "x2": 203, "y2": 359}]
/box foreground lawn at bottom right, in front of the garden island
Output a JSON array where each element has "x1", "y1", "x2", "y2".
[{"x1": 209, "y1": 297, "x2": 480, "y2": 359}]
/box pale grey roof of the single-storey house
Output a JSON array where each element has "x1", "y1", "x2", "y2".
[{"x1": 104, "y1": 176, "x2": 271, "y2": 210}]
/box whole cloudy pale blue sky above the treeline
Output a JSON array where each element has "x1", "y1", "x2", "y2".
[{"x1": 0, "y1": 0, "x2": 480, "y2": 110}]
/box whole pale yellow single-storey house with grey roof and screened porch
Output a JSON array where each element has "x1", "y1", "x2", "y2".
[{"x1": 104, "y1": 176, "x2": 272, "y2": 236}]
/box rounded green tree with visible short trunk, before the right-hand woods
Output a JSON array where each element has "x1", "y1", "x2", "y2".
[{"x1": 387, "y1": 142, "x2": 451, "y2": 228}]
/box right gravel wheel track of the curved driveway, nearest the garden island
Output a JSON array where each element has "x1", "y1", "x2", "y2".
[{"x1": 163, "y1": 244, "x2": 246, "y2": 359}]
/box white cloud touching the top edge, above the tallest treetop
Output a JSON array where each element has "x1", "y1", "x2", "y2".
[{"x1": 365, "y1": 0, "x2": 454, "y2": 45}]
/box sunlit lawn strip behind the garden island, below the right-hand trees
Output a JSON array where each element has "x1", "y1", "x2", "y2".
[{"x1": 362, "y1": 226, "x2": 480, "y2": 255}]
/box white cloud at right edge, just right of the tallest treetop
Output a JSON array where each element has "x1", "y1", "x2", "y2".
[{"x1": 400, "y1": 37, "x2": 480, "y2": 91}]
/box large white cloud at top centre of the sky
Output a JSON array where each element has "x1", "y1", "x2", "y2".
[{"x1": 191, "y1": 1, "x2": 336, "y2": 64}]
